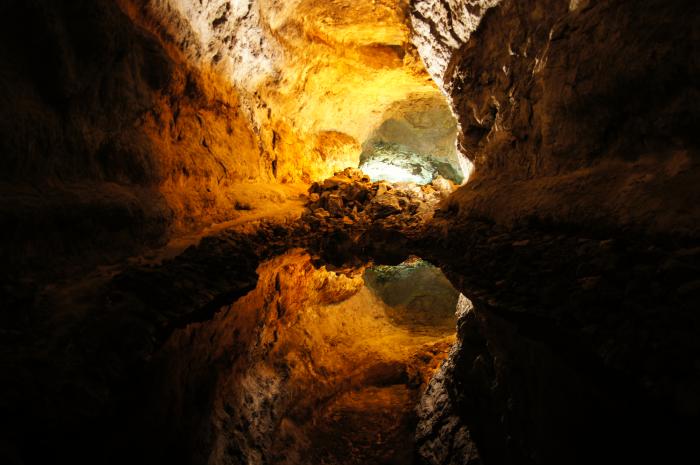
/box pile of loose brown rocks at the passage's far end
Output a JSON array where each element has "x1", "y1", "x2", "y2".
[{"x1": 302, "y1": 168, "x2": 453, "y2": 230}]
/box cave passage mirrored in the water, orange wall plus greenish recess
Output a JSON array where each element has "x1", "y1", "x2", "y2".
[{"x1": 152, "y1": 249, "x2": 460, "y2": 464}]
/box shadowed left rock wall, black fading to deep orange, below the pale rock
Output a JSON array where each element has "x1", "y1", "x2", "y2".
[{"x1": 0, "y1": 0, "x2": 272, "y2": 274}]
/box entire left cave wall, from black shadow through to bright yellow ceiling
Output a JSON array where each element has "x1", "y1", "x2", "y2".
[{"x1": 0, "y1": 0, "x2": 464, "y2": 280}]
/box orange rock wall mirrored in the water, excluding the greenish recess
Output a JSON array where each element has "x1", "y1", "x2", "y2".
[{"x1": 129, "y1": 250, "x2": 454, "y2": 464}]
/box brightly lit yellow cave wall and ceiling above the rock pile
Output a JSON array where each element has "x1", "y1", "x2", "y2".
[{"x1": 253, "y1": 0, "x2": 438, "y2": 183}]
